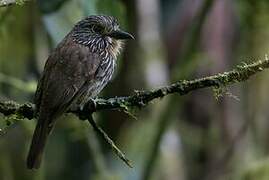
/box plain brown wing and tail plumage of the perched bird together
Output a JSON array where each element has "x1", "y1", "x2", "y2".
[{"x1": 27, "y1": 36, "x2": 101, "y2": 169}]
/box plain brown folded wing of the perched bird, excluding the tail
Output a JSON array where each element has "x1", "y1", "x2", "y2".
[{"x1": 35, "y1": 38, "x2": 101, "y2": 119}]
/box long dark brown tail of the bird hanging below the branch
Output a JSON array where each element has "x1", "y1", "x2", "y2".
[{"x1": 27, "y1": 116, "x2": 52, "y2": 169}]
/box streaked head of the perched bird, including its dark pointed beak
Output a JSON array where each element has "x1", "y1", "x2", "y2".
[{"x1": 72, "y1": 15, "x2": 134, "y2": 54}]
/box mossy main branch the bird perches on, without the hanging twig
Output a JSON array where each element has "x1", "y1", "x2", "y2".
[{"x1": 0, "y1": 57, "x2": 269, "y2": 119}]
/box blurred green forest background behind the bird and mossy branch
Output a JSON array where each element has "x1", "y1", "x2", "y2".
[{"x1": 0, "y1": 0, "x2": 269, "y2": 180}]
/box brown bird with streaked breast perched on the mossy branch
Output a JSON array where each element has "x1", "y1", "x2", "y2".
[{"x1": 26, "y1": 15, "x2": 134, "y2": 169}]
